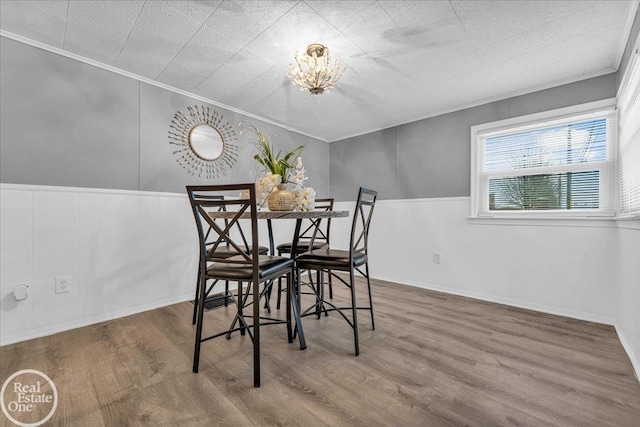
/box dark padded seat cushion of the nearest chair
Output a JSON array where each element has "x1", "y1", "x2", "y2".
[{"x1": 207, "y1": 255, "x2": 293, "y2": 282}]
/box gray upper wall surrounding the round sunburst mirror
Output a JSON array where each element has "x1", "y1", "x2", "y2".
[{"x1": 0, "y1": 37, "x2": 329, "y2": 197}]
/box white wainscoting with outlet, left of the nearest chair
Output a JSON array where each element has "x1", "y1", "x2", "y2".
[{"x1": 0, "y1": 184, "x2": 197, "y2": 345}]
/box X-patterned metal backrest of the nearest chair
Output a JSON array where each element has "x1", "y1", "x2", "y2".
[{"x1": 187, "y1": 183, "x2": 259, "y2": 280}]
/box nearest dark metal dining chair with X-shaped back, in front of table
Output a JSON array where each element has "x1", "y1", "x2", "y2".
[{"x1": 187, "y1": 184, "x2": 294, "y2": 387}]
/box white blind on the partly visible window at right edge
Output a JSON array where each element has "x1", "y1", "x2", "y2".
[{"x1": 618, "y1": 49, "x2": 640, "y2": 216}]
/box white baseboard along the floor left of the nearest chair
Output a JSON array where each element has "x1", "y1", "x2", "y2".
[{"x1": 0, "y1": 293, "x2": 193, "y2": 347}]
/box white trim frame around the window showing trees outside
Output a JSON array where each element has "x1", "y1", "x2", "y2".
[{"x1": 469, "y1": 98, "x2": 618, "y2": 220}]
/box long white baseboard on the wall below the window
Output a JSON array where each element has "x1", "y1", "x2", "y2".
[{"x1": 371, "y1": 274, "x2": 615, "y2": 326}]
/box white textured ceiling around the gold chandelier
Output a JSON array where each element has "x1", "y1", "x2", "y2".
[{"x1": 0, "y1": 0, "x2": 638, "y2": 141}]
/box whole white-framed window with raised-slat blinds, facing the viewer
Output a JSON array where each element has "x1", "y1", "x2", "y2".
[{"x1": 471, "y1": 100, "x2": 617, "y2": 217}]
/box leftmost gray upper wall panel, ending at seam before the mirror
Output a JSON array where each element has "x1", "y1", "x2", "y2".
[{"x1": 0, "y1": 37, "x2": 140, "y2": 190}]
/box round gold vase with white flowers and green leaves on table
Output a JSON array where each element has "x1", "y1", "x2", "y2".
[{"x1": 242, "y1": 123, "x2": 315, "y2": 211}]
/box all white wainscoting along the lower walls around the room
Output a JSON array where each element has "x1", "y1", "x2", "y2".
[{"x1": 0, "y1": 184, "x2": 640, "y2": 380}]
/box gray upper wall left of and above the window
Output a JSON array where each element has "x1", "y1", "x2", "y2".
[{"x1": 329, "y1": 73, "x2": 617, "y2": 201}]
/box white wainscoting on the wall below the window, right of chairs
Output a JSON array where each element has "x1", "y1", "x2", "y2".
[{"x1": 332, "y1": 197, "x2": 618, "y2": 325}]
